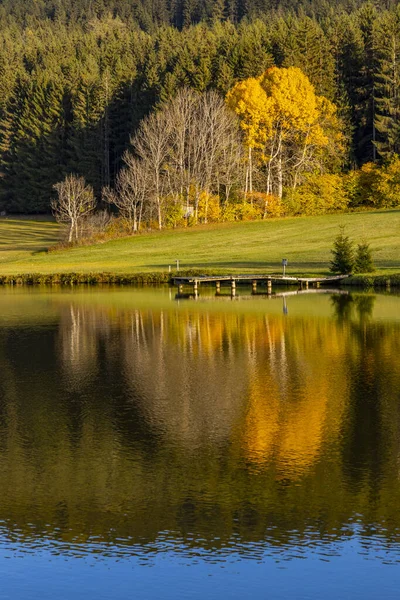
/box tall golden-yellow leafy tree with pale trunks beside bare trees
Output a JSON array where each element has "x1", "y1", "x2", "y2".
[{"x1": 226, "y1": 67, "x2": 344, "y2": 198}]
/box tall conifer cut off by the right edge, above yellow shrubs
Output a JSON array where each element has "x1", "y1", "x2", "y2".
[{"x1": 375, "y1": 7, "x2": 400, "y2": 158}]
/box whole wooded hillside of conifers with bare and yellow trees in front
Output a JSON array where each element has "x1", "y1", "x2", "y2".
[{"x1": 0, "y1": 0, "x2": 400, "y2": 225}]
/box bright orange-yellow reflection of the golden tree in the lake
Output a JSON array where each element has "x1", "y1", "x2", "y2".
[{"x1": 243, "y1": 321, "x2": 347, "y2": 478}]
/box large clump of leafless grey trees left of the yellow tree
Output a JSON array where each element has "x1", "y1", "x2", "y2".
[{"x1": 111, "y1": 88, "x2": 243, "y2": 229}]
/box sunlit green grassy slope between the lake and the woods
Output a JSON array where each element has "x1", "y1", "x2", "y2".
[{"x1": 0, "y1": 210, "x2": 400, "y2": 283}]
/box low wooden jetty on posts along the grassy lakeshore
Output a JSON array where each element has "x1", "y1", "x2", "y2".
[{"x1": 172, "y1": 275, "x2": 349, "y2": 296}]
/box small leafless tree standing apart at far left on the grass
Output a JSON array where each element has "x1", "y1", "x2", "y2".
[{"x1": 51, "y1": 174, "x2": 96, "y2": 242}]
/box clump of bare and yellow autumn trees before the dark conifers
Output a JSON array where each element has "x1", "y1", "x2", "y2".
[{"x1": 54, "y1": 67, "x2": 350, "y2": 233}]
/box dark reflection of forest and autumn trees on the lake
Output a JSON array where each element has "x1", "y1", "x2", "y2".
[{"x1": 0, "y1": 295, "x2": 400, "y2": 547}]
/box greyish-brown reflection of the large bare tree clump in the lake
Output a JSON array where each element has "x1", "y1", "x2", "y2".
[{"x1": 124, "y1": 312, "x2": 247, "y2": 450}]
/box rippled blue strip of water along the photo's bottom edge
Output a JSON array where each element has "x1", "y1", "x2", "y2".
[{"x1": 0, "y1": 540, "x2": 400, "y2": 600}]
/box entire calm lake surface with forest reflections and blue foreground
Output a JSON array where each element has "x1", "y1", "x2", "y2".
[{"x1": 0, "y1": 288, "x2": 400, "y2": 600}]
